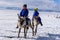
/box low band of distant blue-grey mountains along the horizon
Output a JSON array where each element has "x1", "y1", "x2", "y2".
[{"x1": 0, "y1": 7, "x2": 60, "y2": 12}]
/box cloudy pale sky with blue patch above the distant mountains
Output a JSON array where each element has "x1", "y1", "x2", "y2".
[{"x1": 0, "y1": 0, "x2": 60, "y2": 10}]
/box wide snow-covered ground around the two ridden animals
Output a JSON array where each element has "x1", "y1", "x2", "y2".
[{"x1": 0, "y1": 10, "x2": 60, "y2": 40}]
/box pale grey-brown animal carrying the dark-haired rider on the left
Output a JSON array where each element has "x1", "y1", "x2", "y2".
[{"x1": 17, "y1": 15, "x2": 34, "y2": 38}]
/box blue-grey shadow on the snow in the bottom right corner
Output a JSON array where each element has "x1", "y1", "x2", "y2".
[{"x1": 36, "y1": 33, "x2": 60, "y2": 40}]
